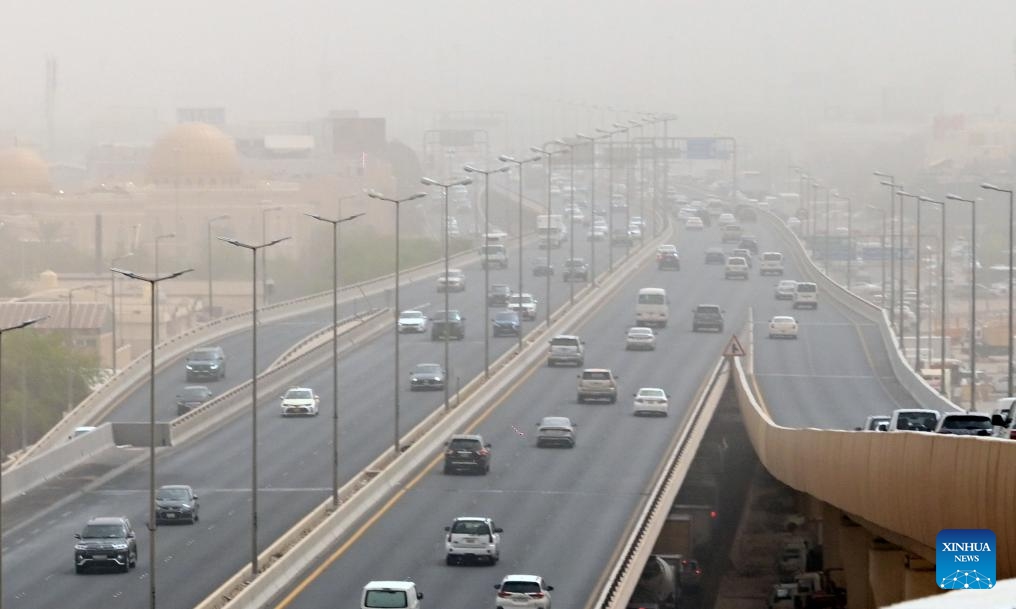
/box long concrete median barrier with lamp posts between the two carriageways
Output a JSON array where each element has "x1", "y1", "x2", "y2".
[{"x1": 195, "y1": 206, "x2": 673, "y2": 609}]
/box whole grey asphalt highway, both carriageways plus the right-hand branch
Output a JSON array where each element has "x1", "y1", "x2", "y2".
[{"x1": 4, "y1": 209, "x2": 922, "y2": 609}]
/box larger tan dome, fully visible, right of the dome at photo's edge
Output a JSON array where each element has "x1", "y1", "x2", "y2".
[{"x1": 148, "y1": 123, "x2": 240, "y2": 186}]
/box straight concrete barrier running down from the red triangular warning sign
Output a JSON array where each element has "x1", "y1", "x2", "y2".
[{"x1": 587, "y1": 358, "x2": 729, "y2": 609}]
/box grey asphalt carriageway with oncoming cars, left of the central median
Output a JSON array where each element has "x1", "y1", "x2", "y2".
[{"x1": 3, "y1": 212, "x2": 623, "y2": 608}]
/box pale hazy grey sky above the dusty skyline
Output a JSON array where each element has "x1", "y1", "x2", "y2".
[{"x1": 0, "y1": 0, "x2": 1016, "y2": 147}]
